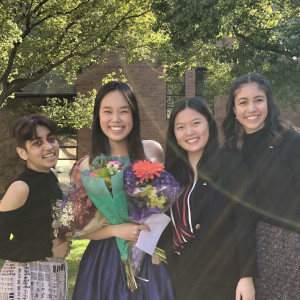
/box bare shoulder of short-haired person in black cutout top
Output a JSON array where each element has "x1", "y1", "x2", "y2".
[{"x1": 0, "y1": 180, "x2": 29, "y2": 211}]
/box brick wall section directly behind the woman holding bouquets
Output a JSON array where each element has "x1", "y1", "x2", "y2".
[{"x1": 77, "y1": 55, "x2": 168, "y2": 158}]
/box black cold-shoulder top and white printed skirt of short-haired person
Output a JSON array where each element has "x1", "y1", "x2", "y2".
[{"x1": 0, "y1": 168, "x2": 67, "y2": 300}]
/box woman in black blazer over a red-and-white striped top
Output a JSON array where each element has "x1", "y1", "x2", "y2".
[{"x1": 164, "y1": 98, "x2": 256, "y2": 300}]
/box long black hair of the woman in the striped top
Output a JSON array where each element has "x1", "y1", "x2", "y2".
[{"x1": 165, "y1": 97, "x2": 219, "y2": 185}]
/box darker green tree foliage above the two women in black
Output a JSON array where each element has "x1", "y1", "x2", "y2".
[{"x1": 155, "y1": 0, "x2": 300, "y2": 105}]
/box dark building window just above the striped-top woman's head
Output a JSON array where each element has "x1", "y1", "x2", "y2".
[{"x1": 167, "y1": 76, "x2": 185, "y2": 119}]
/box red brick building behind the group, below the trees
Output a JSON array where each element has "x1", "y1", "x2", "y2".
[{"x1": 0, "y1": 55, "x2": 300, "y2": 196}]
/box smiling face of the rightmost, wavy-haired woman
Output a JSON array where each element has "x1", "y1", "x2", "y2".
[{"x1": 233, "y1": 82, "x2": 268, "y2": 134}]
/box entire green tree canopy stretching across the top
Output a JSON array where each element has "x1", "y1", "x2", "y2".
[{"x1": 0, "y1": 0, "x2": 300, "y2": 115}]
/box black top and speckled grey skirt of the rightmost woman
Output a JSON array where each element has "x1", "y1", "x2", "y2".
[{"x1": 242, "y1": 128, "x2": 300, "y2": 300}]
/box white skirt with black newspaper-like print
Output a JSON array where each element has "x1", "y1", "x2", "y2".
[{"x1": 0, "y1": 258, "x2": 68, "y2": 300}]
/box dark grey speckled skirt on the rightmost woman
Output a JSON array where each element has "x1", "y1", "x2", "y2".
[{"x1": 255, "y1": 222, "x2": 300, "y2": 300}]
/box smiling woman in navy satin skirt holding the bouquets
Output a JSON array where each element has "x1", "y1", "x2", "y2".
[{"x1": 73, "y1": 81, "x2": 174, "y2": 300}]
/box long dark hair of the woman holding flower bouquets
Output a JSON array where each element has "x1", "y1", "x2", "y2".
[{"x1": 92, "y1": 81, "x2": 145, "y2": 160}]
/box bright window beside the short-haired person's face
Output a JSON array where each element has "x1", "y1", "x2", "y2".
[{"x1": 55, "y1": 130, "x2": 78, "y2": 188}]
